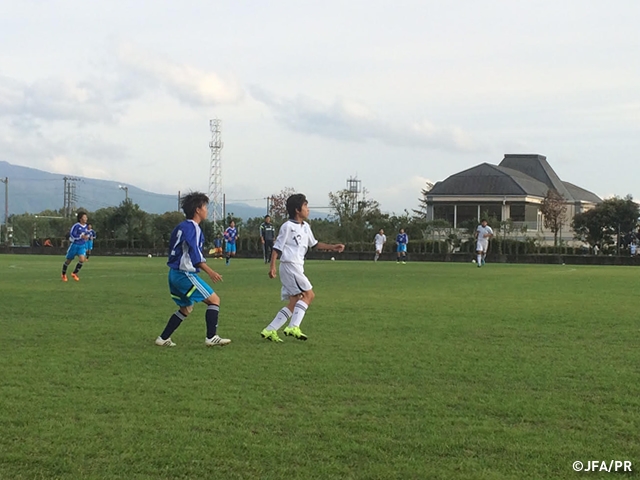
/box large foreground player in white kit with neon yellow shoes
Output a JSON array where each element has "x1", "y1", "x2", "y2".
[{"x1": 260, "y1": 193, "x2": 344, "y2": 342}]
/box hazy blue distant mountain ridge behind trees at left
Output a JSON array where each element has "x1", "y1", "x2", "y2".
[{"x1": 0, "y1": 161, "x2": 265, "y2": 220}]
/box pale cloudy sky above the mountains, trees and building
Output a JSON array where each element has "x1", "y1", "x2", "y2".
[{"x1": 0, "y1": 0, "x2": 640, "y2": 213}]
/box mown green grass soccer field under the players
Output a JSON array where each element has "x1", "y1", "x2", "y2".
[{"x1": 0, "y1": 255, "x2": 640, "y2": 480}]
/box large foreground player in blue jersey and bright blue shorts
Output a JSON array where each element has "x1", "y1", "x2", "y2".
[{"x1": 156, "y1": 192, "x2": 231, "y2": 347}]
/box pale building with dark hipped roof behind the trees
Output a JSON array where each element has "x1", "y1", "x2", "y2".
[{"x1": 426, "y1": 154, "x2": 602, "y2": 238}]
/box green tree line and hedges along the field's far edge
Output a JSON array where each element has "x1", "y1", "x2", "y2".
[{"x1": 2, "y1": 188, "x2": 640, "y2": 253}]
